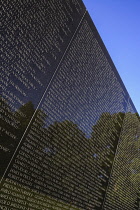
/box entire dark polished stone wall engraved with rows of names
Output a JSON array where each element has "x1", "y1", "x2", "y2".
[{"x1": 0, "y1": 0, "x2": 140, "y2": 210}]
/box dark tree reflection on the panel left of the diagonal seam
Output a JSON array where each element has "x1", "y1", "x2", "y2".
[{"x1": 0, "y1": 100, "x2": 35, "y2": 146}]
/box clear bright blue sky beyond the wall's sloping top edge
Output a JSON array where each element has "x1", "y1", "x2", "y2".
[{"x1": 83, "y1": 0, "x2": 140, "y2": 114}]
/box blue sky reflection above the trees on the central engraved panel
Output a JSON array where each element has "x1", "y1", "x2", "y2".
[{"x1": 36, "y1": 12, "x2": 136, "y2": 137}]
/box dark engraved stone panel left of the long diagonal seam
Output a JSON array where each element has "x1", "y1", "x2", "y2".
[{"x1": 0, "y1": 0, "x2": 85, "y2": 176}]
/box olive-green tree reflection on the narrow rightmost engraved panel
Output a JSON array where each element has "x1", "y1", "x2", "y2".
[{"x1": 103, "y1": 113, "x2": 140, "y2": 209}]
